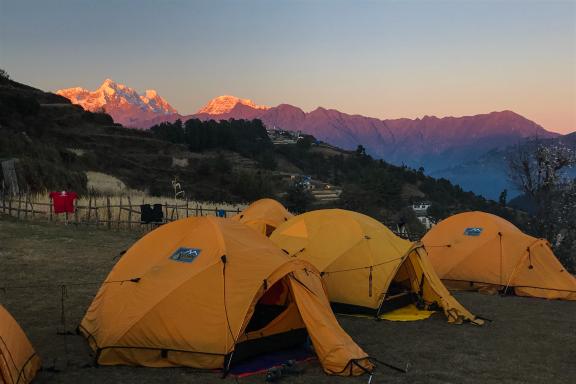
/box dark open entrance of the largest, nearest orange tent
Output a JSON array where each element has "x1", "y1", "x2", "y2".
[{"x1": 231, "y1": 276, "x2": 308, "y2": 366}]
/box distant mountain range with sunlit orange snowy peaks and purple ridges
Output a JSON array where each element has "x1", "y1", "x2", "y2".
[{"x1": 57, "y1": 79, "x2": 560, "y2": 198}]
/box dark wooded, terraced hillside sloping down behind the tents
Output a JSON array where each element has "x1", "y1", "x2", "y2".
[{"x1": 0, "y1": 75, "x2": 514, "y2": 231}]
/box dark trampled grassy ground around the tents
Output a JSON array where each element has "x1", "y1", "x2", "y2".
[{"x1": 0, "y1": 217, "x2": 576, "y2": 384}]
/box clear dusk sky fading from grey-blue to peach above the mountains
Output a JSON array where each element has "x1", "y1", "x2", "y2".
[{"x1": 0, "y1": 0, "x2": 576, "y2": 132}]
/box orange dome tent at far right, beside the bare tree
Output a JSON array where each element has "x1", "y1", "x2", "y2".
[{"x1": 422, "y1": 212, "x2": 576, "y2": 300}]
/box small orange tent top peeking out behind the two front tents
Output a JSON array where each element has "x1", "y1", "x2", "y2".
[{"x1": 231, "y1": 199, "x2": 293, "y2": 236}]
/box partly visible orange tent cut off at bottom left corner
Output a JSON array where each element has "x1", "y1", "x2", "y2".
[{"x1": 0, "y1": 305, "x2": 40, "y2": 384}]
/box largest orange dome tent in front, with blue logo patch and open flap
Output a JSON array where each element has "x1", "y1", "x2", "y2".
[{"x1": 79, "y1": 217, "x2": 372, "y2": 375}]
